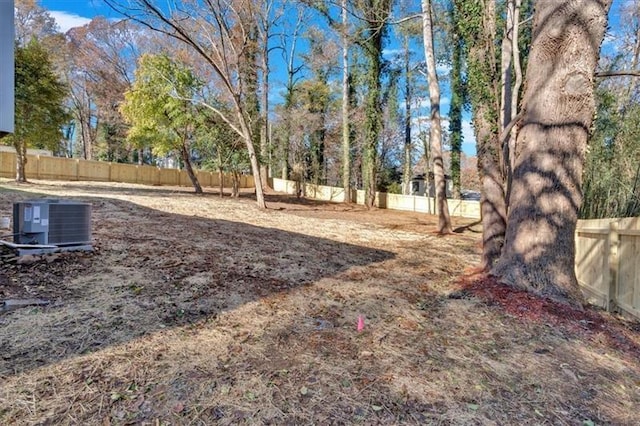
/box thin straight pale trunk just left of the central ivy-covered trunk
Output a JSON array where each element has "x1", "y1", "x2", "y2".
[{"x1": 342, "y1": 0, "x2": 351, "y2": 204}]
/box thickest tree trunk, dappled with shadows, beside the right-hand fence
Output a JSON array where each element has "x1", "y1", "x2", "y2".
[{"x1": 492, "y1": 0, "x2": 612, "y2": 302}]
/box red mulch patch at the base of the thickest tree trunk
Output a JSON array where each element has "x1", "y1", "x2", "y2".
[{"x1": 457, "y1": 274, "x2": 640, "y2": 359}]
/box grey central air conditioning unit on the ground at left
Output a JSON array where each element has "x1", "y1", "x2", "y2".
[{"x1": 13, "y1": 198, "x2": 91, "y2": 246}]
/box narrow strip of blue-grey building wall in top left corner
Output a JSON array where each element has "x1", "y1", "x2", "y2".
[{"x1": 0, "y1": 0, "x2": 15, "y2": 137}]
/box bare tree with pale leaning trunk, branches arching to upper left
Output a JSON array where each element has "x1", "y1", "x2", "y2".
[{"x1": 105, "y1": 0, "x2": 266, "y2": 208}]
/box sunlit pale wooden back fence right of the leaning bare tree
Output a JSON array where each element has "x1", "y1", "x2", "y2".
[{"x1": 272, "y1": 178, "x2": 480, "y2": 219}]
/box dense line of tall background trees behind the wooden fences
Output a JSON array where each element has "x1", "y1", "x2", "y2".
[{"x1": 6, "y1": 0, "x2": 479, "y2": 200}]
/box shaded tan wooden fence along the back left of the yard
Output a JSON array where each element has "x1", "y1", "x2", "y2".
[{"x1": 0, "y1": 151, "x2": 253, "y2": 188}]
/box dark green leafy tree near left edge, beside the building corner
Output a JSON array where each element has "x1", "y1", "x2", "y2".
[{"x1": 9, "y1": 38, "x2": 70, "y2": 182}]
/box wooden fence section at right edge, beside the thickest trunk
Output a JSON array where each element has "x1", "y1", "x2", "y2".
[{"x1": 576, "y1": 217, "x2": 640, "y2": 317}]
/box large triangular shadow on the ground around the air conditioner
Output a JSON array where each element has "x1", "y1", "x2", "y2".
[{"x1": 0, "y1": 188, "x2": 394, "y2": 377}]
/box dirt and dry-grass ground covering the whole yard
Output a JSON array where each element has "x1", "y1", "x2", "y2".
[{"x1": 0, "y1": 179, "x2": 640, "y2": 426}]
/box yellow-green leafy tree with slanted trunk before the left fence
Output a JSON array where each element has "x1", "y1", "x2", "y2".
[{"x1": 121, "y1": 54, "x2": 203, "y2": 193}]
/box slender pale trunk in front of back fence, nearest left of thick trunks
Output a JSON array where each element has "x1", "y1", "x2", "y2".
[{"x1": 422, "y1": 0, "x2": 452, "y2": 234}]
